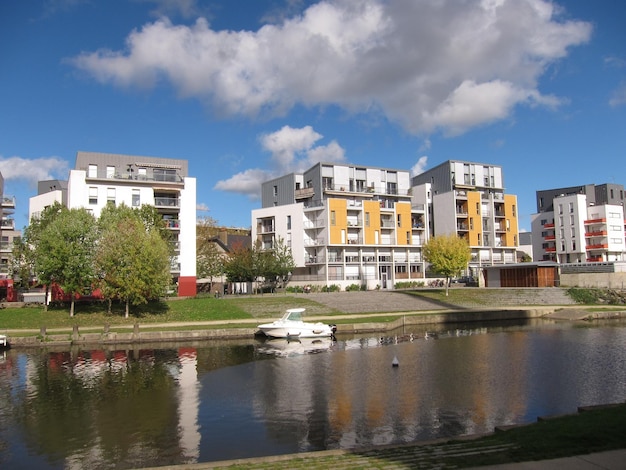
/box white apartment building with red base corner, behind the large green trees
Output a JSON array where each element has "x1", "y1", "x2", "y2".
[{"x1": 29, "y1": 152, "x2": 196, "y2": 296}]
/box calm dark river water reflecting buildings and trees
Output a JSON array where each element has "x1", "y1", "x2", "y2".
[{"x1": 0, "y1": 320, "x2": 626, "y2": 469}]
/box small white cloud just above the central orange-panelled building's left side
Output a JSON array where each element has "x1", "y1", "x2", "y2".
[{"x1": 215, "y1": 126, "x2": 345, "y2": 199}]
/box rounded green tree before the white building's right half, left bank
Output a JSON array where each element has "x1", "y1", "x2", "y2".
[{"x1": 96, "y1": 215, "x2": 171, "y2": 318}]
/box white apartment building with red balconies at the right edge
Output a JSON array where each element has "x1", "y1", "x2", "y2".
[{"x1": 531, "y1": 183, "x2": 626, "y2": 264}]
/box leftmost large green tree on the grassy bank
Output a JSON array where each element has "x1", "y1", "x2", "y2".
[{"x1": 34, "y1": 208, "x2": 97, "y2": 316}]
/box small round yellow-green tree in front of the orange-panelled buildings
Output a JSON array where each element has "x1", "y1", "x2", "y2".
[{"x1": 422, "y1": 234, "x2": 472, "y2": 296}]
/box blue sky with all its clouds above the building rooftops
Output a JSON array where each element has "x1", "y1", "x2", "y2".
[{"x1": 0, "y1": 0, "x2": 626, "y2": 230}]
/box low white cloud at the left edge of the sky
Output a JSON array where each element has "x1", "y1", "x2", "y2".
[{"x1": 0, "y1": 156, "x2": 69, "y2": 187}]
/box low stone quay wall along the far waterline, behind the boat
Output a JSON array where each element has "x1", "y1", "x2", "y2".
[{"x1": 5, "y1": 306, "x2": 626, "y2": 348}]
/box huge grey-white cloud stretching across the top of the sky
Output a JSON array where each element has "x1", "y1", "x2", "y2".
[{"x1": 71, "y1": 0, "x2": 592, "y2": 135}]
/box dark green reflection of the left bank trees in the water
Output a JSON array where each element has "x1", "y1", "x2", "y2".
[{"x1": 20, "y1": 350, "x2": 180, "y2": 468}]
